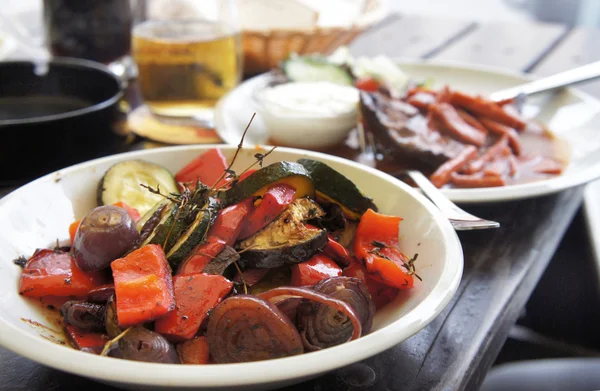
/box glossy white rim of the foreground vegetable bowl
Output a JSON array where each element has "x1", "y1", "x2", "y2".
[{"x1": 0, "y1": 145, "x2": 463, "y2": 388}]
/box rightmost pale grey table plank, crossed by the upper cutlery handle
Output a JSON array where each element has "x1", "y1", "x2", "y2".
[{"x1": 533, "y1": 28, "x2": 600, "y2": 97}]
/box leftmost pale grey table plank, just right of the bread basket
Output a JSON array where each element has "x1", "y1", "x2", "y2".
[{"x1": 350, "y1": 15, "x2": 474, "y2": 58}]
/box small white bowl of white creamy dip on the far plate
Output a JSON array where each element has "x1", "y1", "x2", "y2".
[{"x1": 257, "y1": 82, "x2": 360, "y2": 149}]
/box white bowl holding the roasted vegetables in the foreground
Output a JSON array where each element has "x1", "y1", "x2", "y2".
[{"x1": 0, "y1": 145, "x2": 463, "y2": 390}]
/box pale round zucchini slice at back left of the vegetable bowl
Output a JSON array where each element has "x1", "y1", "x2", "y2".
[{"x1": 98, "y1": 160, "x2": 179, "y2": 216}]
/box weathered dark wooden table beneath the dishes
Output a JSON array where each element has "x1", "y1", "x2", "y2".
[{"x1": 0, "y1": 14, "x2": 600, "y2": 391}]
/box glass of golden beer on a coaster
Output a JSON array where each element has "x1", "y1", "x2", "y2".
[{"x1": 132, "y1": 0, "x2": 242, "y2": 126}]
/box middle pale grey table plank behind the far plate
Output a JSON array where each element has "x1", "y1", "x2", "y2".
[{"x1": 435, "y1": 22, "x2": 567, "y2": 70}]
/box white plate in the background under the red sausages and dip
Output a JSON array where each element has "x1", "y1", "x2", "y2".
[{"x1": 215, "y1": 61, "x2": 600, "y2": 203}]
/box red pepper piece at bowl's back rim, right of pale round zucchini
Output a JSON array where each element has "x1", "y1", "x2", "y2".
[{"x1": 175, "y1": 148, "x2": 233, "y2": 187}]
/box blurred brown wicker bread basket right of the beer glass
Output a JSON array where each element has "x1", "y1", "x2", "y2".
[{"x1": 242, "y1": 0, "x2": 386, "y2": 75}]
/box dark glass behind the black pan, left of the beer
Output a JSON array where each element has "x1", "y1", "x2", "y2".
[{"x1": 44, "y1": 0, "x2": 132, "y2": 64}]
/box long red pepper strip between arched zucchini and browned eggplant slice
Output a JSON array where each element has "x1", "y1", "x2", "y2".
[{"x1": 239, "y1": 184, "x2": 296, "y2": 239}]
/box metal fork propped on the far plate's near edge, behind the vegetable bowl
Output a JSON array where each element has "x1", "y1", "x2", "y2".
[{"x1": 358, "y1": 122, "x2": 500, "y2": 231}]
